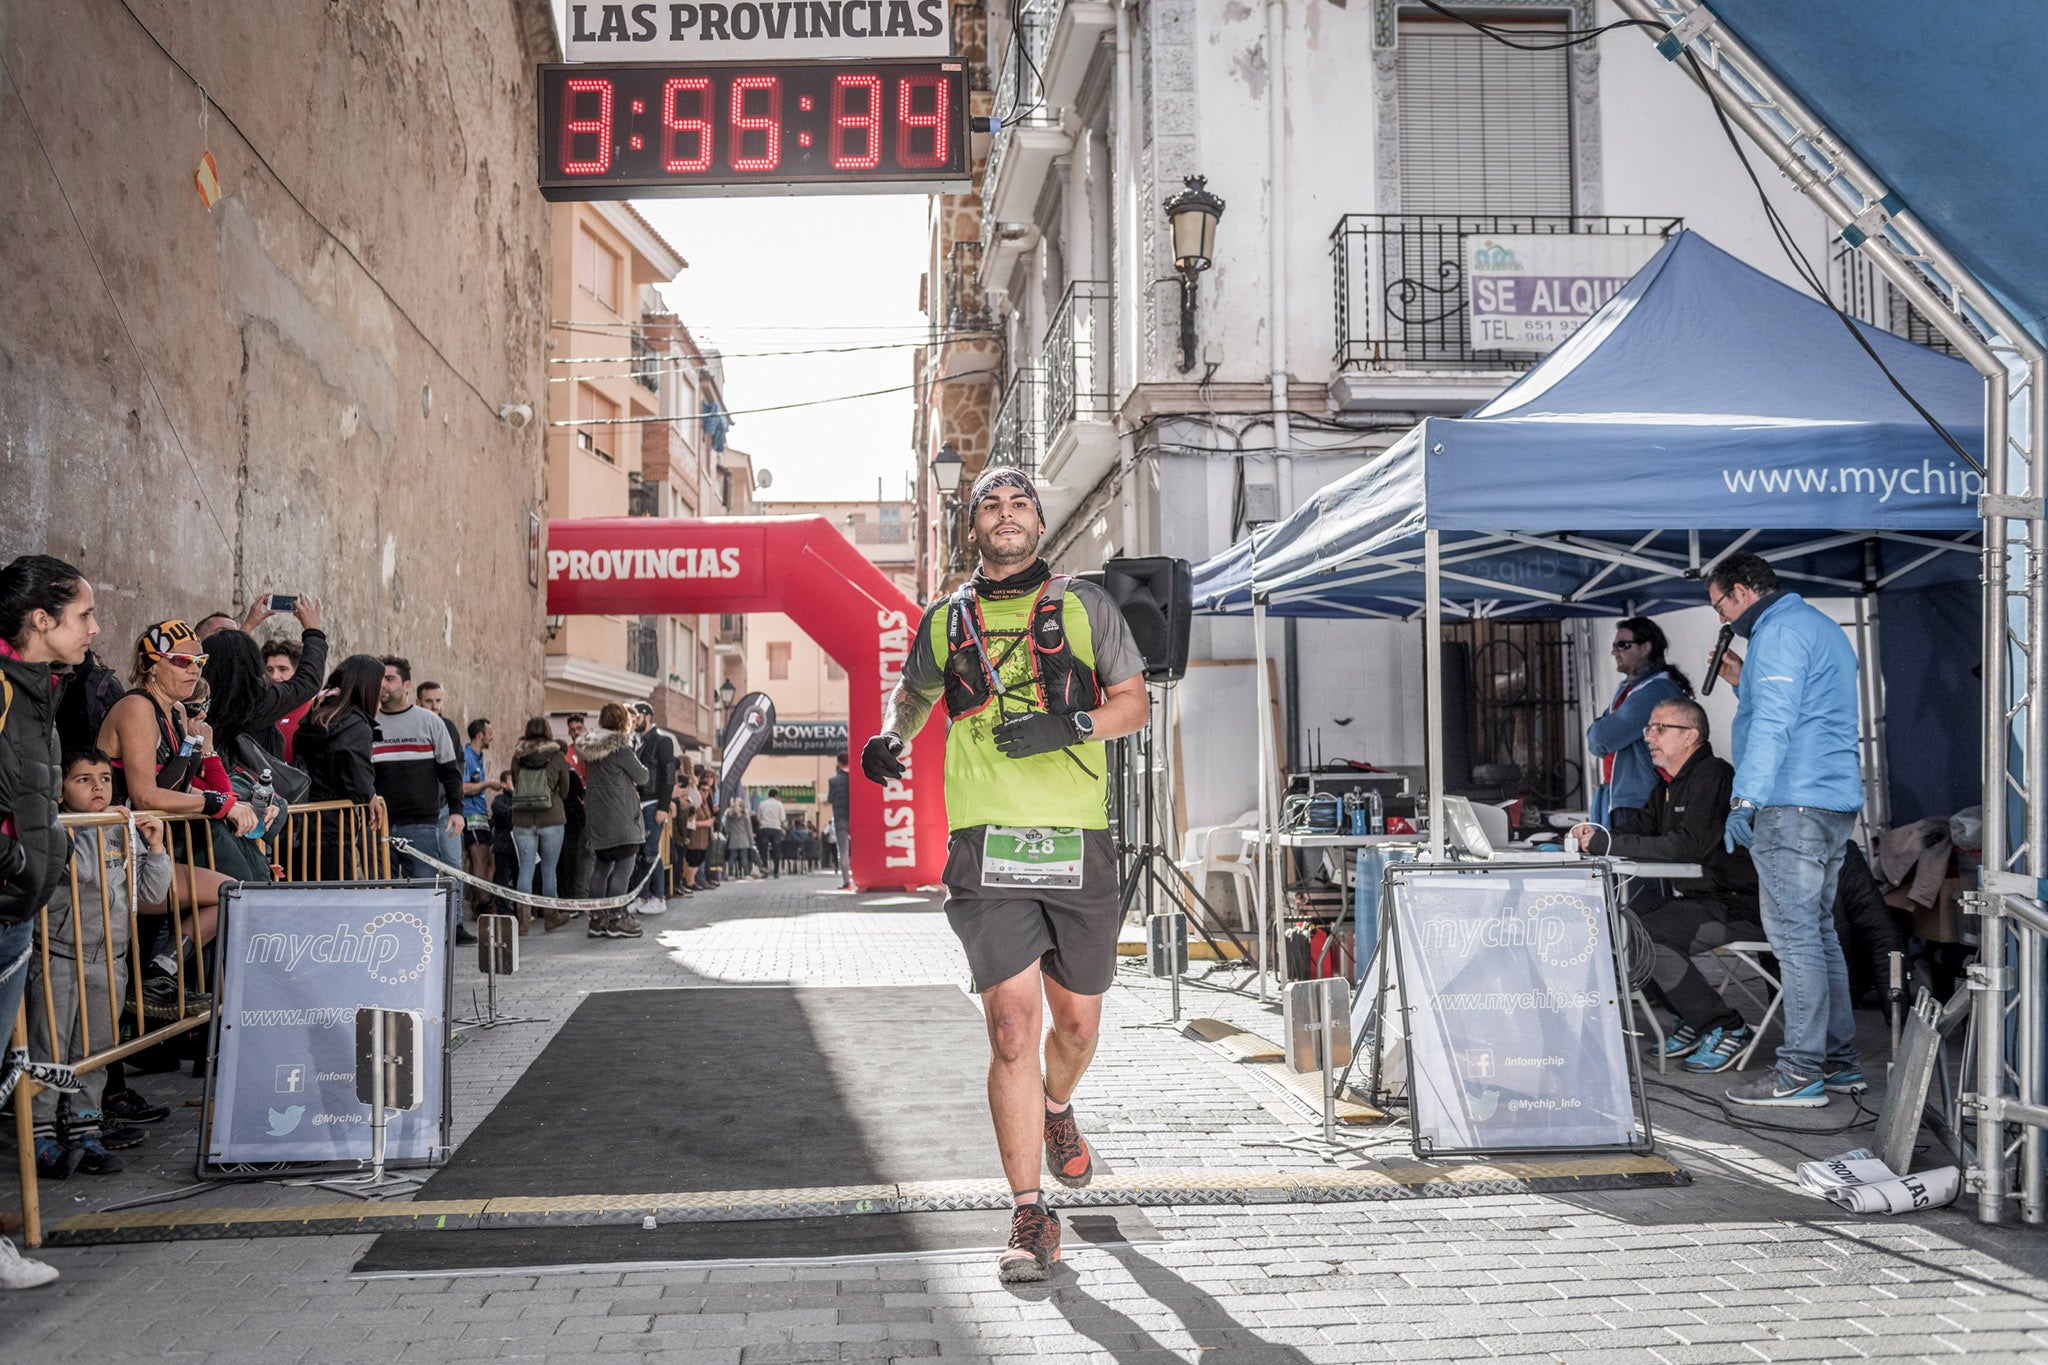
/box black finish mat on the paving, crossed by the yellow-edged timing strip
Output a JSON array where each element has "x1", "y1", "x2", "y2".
[{"x1": 356, "y1": 986, "x2": 1153, "y2": 1271}]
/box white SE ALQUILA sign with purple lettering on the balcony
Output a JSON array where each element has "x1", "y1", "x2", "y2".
[{"x1": 1462, "y1": 233, "x2": 1665, "y2": 352}]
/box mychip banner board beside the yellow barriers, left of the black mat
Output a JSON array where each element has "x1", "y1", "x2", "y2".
[{"x1": 201, "y1": 882, "x2": 451, "y2": 1175}]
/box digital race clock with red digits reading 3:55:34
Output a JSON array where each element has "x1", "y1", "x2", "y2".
[{"x1": 541, "y1": 59, "x2": 973, "y2": 201}]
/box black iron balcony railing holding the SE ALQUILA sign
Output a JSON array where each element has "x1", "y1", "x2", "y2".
[{"x1": 1329, "y1": 213, "x2": 1686, "y2": 370}]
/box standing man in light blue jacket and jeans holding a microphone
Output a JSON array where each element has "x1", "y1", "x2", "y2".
[{"x1": 1706, "y1": 555, "x2": 1866, "y2": 1109}]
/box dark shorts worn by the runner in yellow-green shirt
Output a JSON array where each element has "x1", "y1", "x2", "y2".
[{"x1": 946, "y1": 825, "x2": 1122, "y2": 995}]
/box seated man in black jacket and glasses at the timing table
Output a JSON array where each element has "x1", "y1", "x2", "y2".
[{"x1": 1573, "y1": 698, "x2": 1763, "y2": 1074}]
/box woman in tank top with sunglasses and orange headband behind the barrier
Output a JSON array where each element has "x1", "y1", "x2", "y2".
[{"x1": 100, "y1": 620, "x2": 258, "y2": 1019}]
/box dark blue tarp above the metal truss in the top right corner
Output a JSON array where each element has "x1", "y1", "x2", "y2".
[{"x1": 1712, "y1": 0, "x2": 2048, "y2": 351}]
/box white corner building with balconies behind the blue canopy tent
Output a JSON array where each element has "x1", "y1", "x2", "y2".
[{"x1": 915, "y1": 0, "x2": 1933, "y2": 823}]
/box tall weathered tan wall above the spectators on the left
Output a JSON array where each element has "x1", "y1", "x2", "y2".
[{"x1": 0, "y1": 0, "x2": 555, "y2": 733}]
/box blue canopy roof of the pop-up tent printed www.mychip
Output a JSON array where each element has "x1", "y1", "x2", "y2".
[{"x1": 1194, "y1": 231, "x2": 1985, "y2": 616}]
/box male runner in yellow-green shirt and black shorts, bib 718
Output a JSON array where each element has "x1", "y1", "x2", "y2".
[{"x1": 860, "y1": 469, "x2": 1149, "y2": 1281}]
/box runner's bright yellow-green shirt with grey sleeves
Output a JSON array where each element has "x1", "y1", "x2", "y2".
[{"x1": 903, "y1": 581, "x2": 1145, "y2": 829}]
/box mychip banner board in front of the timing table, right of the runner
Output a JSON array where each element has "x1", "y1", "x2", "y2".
[{"x1": 1386, "y1": 864, "x2": 1651, "y2": 1156}]
